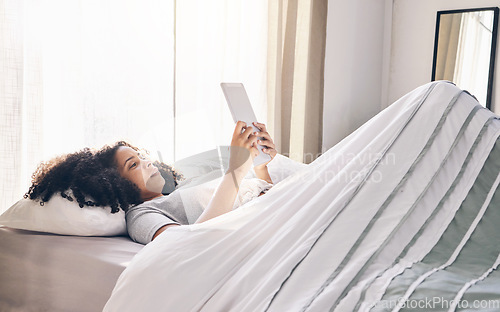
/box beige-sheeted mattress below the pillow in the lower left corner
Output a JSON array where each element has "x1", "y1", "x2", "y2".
[{"x1": 0, "y1": 227, "x2": 144, "y2": 312}]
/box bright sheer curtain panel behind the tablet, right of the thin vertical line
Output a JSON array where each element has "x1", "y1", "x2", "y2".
[{"x1": 175, "y1": 0, "x2": 268, "y2": 159}]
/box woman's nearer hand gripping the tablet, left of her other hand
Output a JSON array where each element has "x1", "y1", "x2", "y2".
[{"x1": 228, "y1": 121, "x2": 259, "y2": 178}]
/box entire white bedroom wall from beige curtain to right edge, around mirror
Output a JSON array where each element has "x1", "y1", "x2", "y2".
[{"x1": 323, "y1": 0, "x2": 500, "y2": 151}]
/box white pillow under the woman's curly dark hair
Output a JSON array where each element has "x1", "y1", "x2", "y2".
[{"x1": 0, "y1": 194, "x2": 127, "y2": 236}]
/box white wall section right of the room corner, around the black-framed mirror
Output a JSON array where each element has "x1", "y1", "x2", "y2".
[{"x1": 388, "y1": 0, "x2": 500, "y2": 114}]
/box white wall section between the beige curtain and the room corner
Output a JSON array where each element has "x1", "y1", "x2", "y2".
[{"x1": 323, "y1": 0, "x2": 392, "y2": 151}]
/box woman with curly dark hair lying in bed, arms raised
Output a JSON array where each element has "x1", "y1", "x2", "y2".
[{"x1": 25, "y1": 121, "x2": 276, "y2": 244}]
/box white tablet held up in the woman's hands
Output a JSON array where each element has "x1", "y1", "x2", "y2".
[{"x1": 220, "y1": 82, "x2": 271, "y2": 166}]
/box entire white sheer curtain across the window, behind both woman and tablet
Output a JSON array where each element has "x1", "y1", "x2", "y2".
[{"x1": 0, "y1": 0, "x2": 267, "y2": 213}]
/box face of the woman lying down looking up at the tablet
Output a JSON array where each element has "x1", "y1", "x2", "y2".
[{"x1": 115, "y1": 146, "x2": 165, "y2": 201}]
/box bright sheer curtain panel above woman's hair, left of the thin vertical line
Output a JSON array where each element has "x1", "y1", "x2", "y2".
[{"x1": 0, "y1": 0, "x2": 174, "y2": 213}]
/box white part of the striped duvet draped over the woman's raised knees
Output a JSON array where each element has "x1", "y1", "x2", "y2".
[{"x1": 104, "y1": 82, "x2": 500, "y2": 312}]
